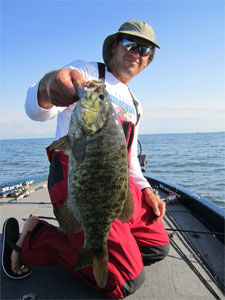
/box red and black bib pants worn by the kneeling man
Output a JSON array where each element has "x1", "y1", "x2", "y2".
[{"x1": 22, "y1": 152, "x2": 169, "y2": 298}]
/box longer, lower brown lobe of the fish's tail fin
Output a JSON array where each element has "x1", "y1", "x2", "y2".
[{"x1": 93, "y1": 250, "x2": 108, "y2": 289}]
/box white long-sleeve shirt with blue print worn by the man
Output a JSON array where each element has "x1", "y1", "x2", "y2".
[{"x1": 25, "y1": 60, "x2": 150, "y2": 189}]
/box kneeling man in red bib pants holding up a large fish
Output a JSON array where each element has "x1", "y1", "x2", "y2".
[{"x1": 4, "y1": 20, "x2": 169, "y2": 298}]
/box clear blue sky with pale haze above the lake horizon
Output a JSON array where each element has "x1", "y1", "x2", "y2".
[{"x1": 0, "y1": 0, "x2": 225, "y2": 139}]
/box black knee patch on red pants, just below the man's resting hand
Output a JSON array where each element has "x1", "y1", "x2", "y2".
[{"x1": 141, "y1": 244, "x2": 170, "y2": 265}]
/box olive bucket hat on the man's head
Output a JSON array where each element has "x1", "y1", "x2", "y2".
[{"x1": 102, "y1": 20, "x2": 160, "y2": 64}]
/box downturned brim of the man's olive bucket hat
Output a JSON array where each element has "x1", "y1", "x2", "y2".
[{"x1": 102, "y1": 31, "x2": 160, "y2": 64}]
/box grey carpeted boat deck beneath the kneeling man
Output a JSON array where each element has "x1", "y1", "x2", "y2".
[{"x1": 0, "y1": 184, "x2": 225, "y2": 300}]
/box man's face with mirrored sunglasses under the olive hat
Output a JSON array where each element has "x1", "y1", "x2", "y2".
[{"x1": 110, "y1": 35, "x2": 151, "y2": 84}]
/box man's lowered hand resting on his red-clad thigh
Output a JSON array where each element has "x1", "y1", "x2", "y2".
[{"x1": 143, "y1": 188, "x2": 166, "y2": 223}]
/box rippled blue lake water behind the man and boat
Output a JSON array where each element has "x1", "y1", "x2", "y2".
[{"x1": 0, "y1": 132, "x2": 225, "y2": 208}]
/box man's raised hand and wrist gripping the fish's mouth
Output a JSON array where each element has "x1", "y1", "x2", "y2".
[{"x1": 38, "y1": 69, "x2": 85, "y2": 109}]
